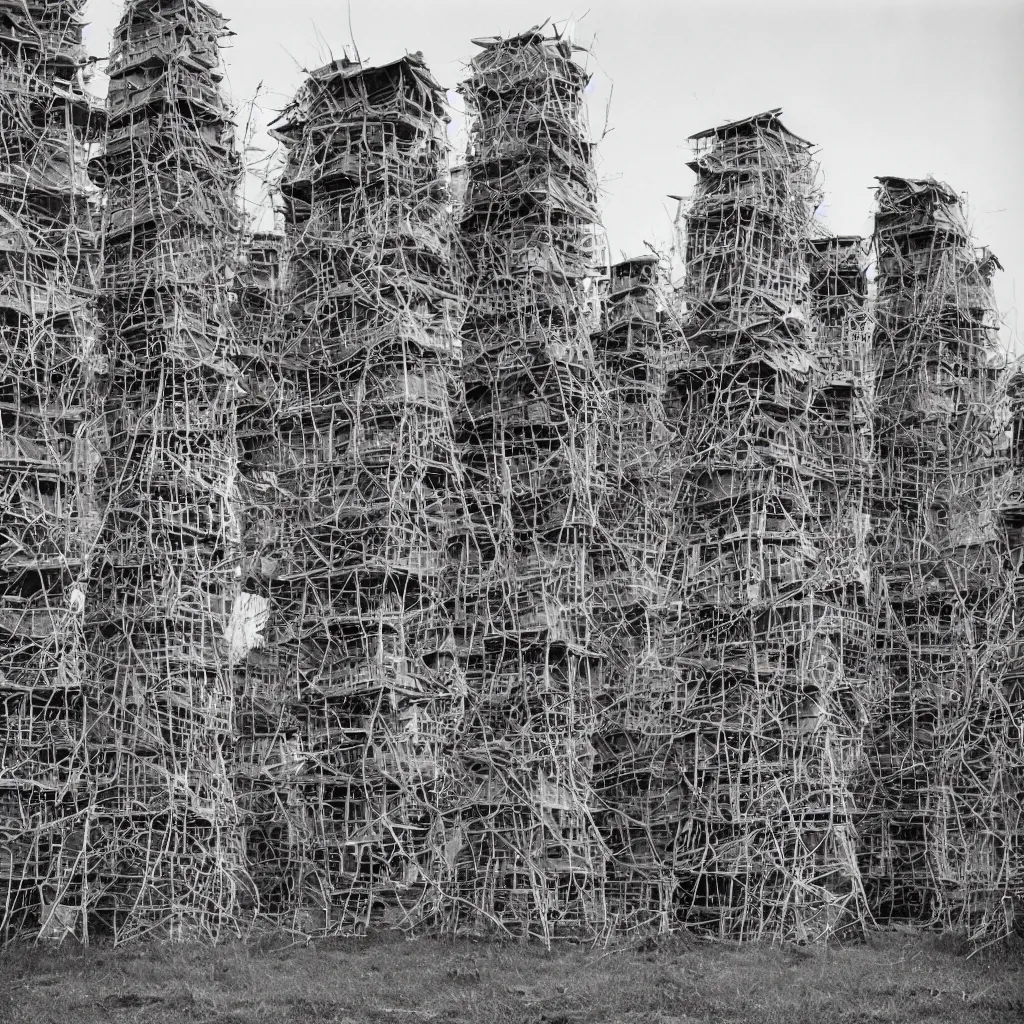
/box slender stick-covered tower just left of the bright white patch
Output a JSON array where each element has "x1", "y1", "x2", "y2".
[{"x1": 87, "y1": 0, "x2": 245, "y2": 939}]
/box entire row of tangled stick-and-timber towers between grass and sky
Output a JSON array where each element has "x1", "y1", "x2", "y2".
[{"x1": 0, "y1": 0, "x2": 1024, "y2": 942}]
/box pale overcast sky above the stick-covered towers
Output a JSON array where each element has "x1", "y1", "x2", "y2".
[{"x1": 87, "y1": 0, "x2": 1024, "y2": 351}]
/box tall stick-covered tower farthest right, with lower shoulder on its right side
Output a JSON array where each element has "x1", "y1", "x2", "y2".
[{"x1": 862, "y1": 177, "x2": 1020, "y2": 933}]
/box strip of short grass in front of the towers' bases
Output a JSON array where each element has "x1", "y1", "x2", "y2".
[{"x1": 0, "y1": 933, "x2": 1024, "y2": 1024}]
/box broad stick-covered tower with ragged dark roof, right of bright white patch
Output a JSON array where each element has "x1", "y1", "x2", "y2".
[{"x1": 254, "y1": 54, "x2": 462, "y2": 931}]
